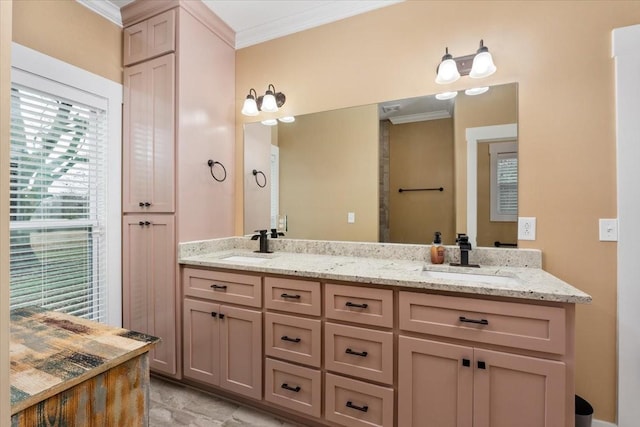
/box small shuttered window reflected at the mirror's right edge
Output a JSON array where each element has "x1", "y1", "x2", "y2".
[{"x1": 489, "y1": 142, "x2": 518, "y2": 222}]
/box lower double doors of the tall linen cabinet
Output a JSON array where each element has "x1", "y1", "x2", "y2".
[{"x1": 122, "y1": 214, "x2": 176, "y2": 375}]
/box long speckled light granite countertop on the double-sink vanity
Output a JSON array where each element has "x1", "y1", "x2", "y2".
[{"x1": 179, "y1": 238, "x2": 591, "y2": 303}]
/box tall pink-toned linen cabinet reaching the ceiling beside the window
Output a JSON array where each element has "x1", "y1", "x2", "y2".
[{"x1": 122, "y1": 0, "x2": 235, "y2": 378}]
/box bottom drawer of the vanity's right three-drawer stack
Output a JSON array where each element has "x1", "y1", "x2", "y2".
[{"x1": 324, "y1": 374, "x2": 393, "y2": 427}]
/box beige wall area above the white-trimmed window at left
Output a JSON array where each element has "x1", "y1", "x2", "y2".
[{"x1": 12, "y1": 0, "x2": 122, "y2": 83}]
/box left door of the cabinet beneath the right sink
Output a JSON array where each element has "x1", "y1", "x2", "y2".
[{"x1": 398, "y1": 336, "x2": 472, "y2": 427}]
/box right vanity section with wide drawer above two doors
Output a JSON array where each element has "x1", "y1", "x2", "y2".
[{"x1": 398, "y1": 292, "x2": 573, "y2": 427}]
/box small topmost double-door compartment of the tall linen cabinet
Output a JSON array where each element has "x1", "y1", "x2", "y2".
[{"x1": 123, "y1": 10, "x2": 176, "y2": 66}]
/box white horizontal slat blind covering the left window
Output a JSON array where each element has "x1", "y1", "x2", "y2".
[{"x1": 10, "y1": 79, "x2": 107, "y2": 321}]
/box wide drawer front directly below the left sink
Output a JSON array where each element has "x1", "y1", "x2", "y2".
[{"x1": 182, "y1": 268, "x2": 262, "y2": 307}]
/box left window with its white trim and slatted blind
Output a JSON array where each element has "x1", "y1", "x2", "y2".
[{"x1": 10, "y1": 44, "x2": 121, "y2": 325}]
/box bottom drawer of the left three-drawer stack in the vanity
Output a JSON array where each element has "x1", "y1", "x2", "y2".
[{"x1": 264, "y1": 358, "x2": 322, "y2": 418}]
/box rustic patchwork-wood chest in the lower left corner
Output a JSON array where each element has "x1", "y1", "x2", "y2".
[{"x1": 9, "y1": 307, "x2": 159, "y2": 427}]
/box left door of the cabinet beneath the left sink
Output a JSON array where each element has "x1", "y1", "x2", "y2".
[{"x1": 183, "y1": 298, "x2": 220, "y2": 385}]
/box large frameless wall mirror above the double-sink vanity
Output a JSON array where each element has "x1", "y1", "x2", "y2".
[{"x1": 244, "y1": 83, "x2": 518, "y2": 247}]
